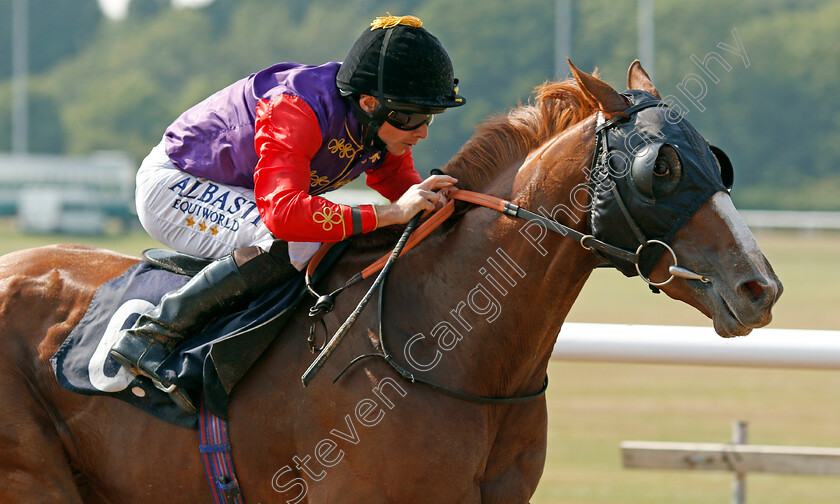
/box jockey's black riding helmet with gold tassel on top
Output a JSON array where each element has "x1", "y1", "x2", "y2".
[{"x1": 335, "y1": 14, "x2": 466, "y2": 150}]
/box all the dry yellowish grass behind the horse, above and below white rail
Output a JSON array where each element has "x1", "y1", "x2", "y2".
[{"x1": 0, "y1": 225, "x2": 840, "y2": 504}]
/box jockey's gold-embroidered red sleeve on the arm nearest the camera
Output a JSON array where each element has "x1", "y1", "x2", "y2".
[{"x1": 254, "y1": 95, "x2": 377, "y2": 242}]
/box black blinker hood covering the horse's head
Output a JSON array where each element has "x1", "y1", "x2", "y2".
[{"x1": 590, "y1": 89, "x2": 731, "y2": 276}]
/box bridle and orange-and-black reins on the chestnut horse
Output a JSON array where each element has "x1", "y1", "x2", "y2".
[{"x1": 301, "y1": 101, "x2": 709, "y2": 404}]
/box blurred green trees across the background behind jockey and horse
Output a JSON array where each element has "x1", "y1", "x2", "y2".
[{"x1": 0, "y1": 0, "x2": 840, "y2": 209}]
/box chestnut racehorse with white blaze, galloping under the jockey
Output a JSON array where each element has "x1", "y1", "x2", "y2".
[{"x1": 0, "y1": 62, "x2": 781, "y2": 504}]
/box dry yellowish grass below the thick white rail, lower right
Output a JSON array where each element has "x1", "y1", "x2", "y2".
[{"x1": 531, "y1": 362, "x2": 840, "y2": 504}]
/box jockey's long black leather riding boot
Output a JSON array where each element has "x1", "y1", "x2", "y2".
[{"x1": 110, "y1": 244, "x2": 297, "y2": 413}]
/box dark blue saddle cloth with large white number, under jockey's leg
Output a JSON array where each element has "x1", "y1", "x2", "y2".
[{"x1": 50, "y1": 262, "x2": 306, "y2": 429}]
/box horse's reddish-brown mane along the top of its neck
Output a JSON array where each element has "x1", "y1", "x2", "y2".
[{"x1": 354, "y1": 78, "x2": 597, "y2": 249}]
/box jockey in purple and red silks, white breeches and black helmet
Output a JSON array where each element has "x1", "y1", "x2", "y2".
[{"x1": 110, "y1": 14, "x2": 465, "y2": 410}]
